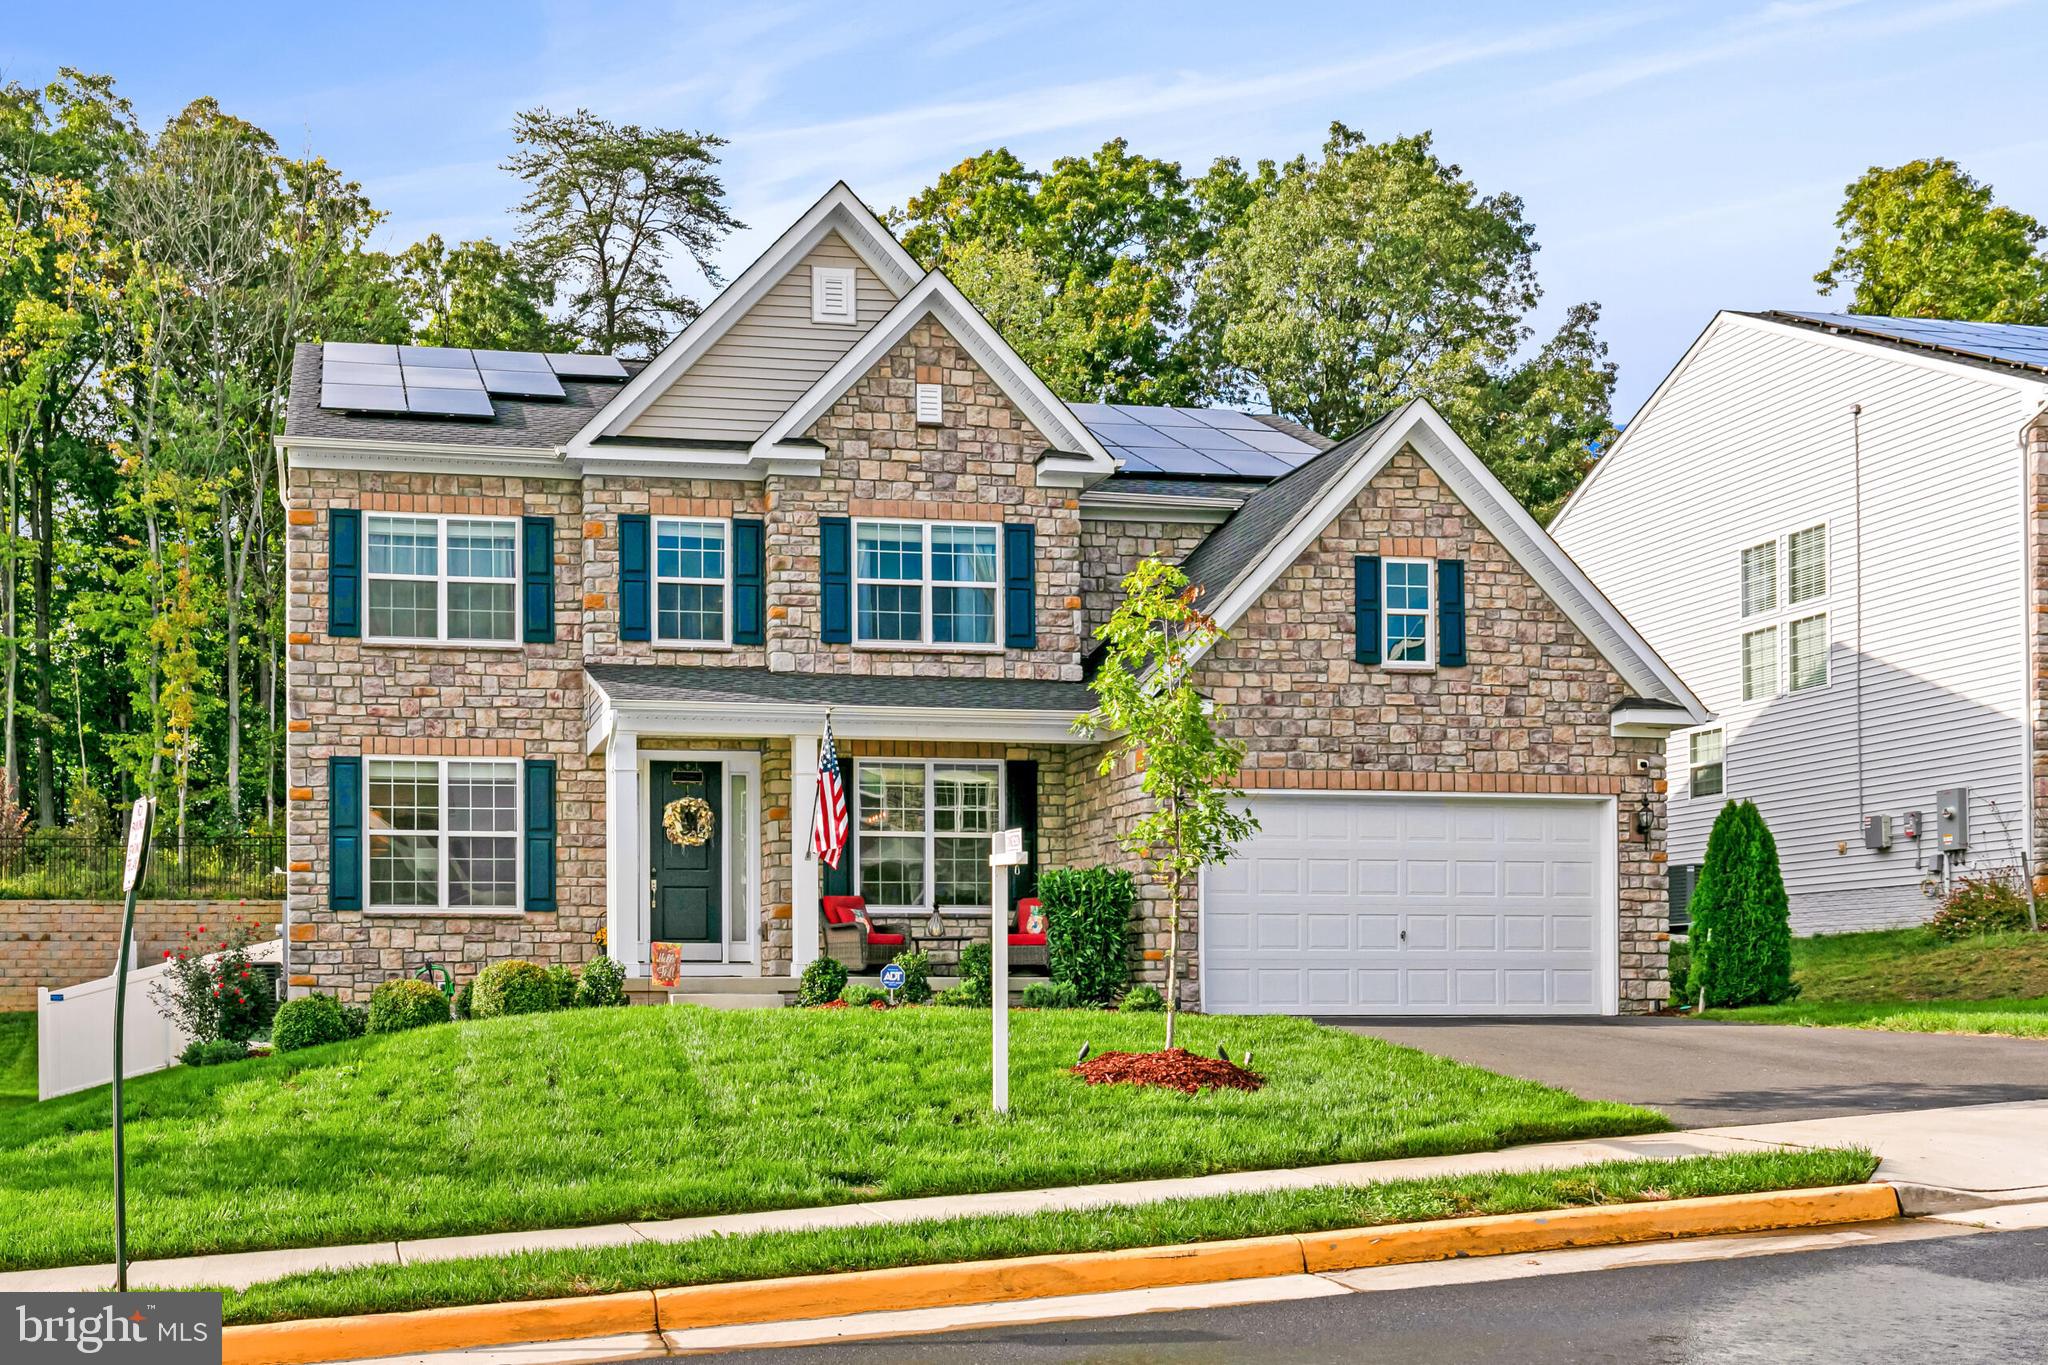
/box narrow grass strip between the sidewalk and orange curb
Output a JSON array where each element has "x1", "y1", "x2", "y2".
[{"x1": 225, "y1": 1148, "x2": 1878, "y2": 1322}]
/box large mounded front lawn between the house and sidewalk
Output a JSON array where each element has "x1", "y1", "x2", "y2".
[{"x1": 0, "y1": 1007, "x2": 1669, "y2": 1269}]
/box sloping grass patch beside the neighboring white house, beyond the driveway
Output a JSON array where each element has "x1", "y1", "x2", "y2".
[{"x1": 1704, "y1": 927, "x2": 2048, "y2": 1038}]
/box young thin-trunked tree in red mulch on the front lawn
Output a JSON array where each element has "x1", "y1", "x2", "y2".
[{"x1": 1073, "y1": 559, "x2": 1260, "y2": 1048}]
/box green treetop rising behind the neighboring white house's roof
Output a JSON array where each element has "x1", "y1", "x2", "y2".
[{"x1": 1812, "y1": 158, "x2": 2048, "y2": 323}]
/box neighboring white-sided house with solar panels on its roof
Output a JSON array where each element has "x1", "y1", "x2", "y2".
[{"x1": 1550, "y1": 313, "x2": 2048, "y2": 933}]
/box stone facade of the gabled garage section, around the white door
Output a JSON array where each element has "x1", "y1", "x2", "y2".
[{"x1": 1075, "y1": 450, "x2": 1667, "y2": 1011}]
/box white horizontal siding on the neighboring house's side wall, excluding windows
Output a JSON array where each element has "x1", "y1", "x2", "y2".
[{"x1": 1552, "y1": 317, "x2": 2038, "y2": 933}]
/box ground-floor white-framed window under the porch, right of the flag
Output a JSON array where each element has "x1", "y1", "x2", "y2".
[{"x1": 854, "y1": 759, "x2": 1001, "y2": 911}]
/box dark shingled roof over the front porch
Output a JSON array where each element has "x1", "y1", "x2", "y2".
[{"x1": 584, "y1": 663, "x2": 1096, "y2": 716}]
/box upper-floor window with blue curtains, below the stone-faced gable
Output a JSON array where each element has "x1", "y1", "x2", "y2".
[{"x1": 854, "y1": 522, "x2": 1001, "y2": 649}]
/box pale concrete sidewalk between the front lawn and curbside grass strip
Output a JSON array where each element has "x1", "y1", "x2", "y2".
[{"x1": 0, "y1": 1101, "x2": 2048, "y2": 1291}]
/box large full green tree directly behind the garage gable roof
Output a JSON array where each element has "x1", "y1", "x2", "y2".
[{"x1": 1196, "y1": 123, "x2": 1614, "y2": 514}]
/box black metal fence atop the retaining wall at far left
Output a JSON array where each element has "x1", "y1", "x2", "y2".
[{"x1": 0, "y1": 835, "x2": 285, "y2": 900}]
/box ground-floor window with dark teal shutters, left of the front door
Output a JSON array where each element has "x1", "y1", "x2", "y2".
[{"x1": 367, "y1": 759, "x2": 518, "y2": 911}]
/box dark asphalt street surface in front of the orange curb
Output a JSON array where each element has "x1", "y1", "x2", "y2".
[{"x1": 688, "y1": 1230, "x2": 2048, "y2": 1365}]
